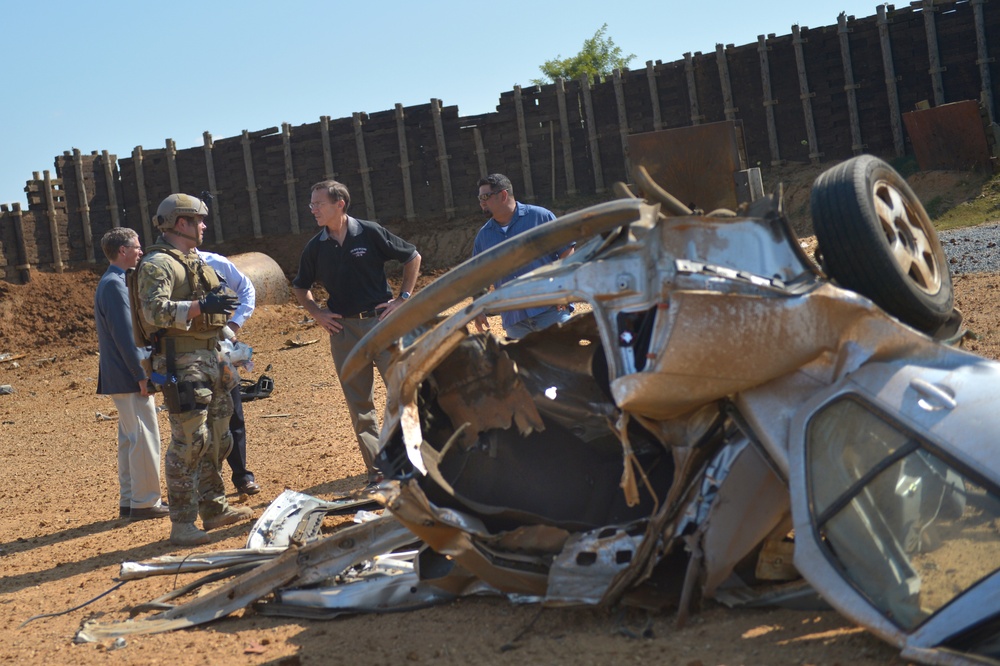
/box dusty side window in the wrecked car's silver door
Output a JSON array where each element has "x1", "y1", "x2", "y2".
[{"x1": 806, "y1": 398, "x2": 1000, "y2": 631}]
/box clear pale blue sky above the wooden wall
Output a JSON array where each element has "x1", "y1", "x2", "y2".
[{"x1": 0, "y1": 0, "x2": 884, "y2": 205}]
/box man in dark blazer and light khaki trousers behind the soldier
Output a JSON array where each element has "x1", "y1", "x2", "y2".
[{"x1": 94, "y1": 227, "x2": 170, "y2": 520}]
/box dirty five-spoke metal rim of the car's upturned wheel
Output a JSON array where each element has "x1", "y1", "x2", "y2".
[{"x1": 872, "y1": 180, "x2": 943, "y2": 295}]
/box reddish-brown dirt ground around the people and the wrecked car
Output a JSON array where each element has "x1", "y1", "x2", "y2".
[{"x1": 0, "y1": 169, "x2": 1000, "y2": 666}]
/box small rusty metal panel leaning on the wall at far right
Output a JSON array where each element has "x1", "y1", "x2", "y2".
[{"x1": 903, "y1": 100, "x2": 992, "y2": 171}]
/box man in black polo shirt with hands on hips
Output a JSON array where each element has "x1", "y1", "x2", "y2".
[{"x1": 292, "y1": 180, "x2": 420, "y2": 484}]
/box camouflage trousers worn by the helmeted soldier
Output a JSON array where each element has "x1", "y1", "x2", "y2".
[{"x1": 153, "y1": 349, "x2": 233, "y2": 523}]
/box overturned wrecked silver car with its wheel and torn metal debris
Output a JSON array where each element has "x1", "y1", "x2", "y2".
[{"x1": 78, "y1": 156, "x2": 1000, "y2": 664}]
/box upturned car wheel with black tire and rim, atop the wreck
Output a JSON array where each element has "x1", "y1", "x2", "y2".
[{"x1": 810, "y1": 155, "x2": 954, "y2": 333}]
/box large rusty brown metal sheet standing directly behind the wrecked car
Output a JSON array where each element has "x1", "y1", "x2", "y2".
[{"x1": 628, "y1": 120, "x2": 747, "y2": 211}]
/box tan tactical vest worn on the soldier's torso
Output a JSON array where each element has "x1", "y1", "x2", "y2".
[{"x1": 126, "y1": 238, "x2": 229, "y2": 347}]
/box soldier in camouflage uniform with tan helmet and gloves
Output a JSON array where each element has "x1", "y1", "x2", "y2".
[{"x1": 134, "y1": 194, "x2": 253, "y2": 546}]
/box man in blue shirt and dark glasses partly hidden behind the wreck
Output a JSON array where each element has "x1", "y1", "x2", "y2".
[{"x1": 472, "y1": 173, "x2": 573, "y2": 340}]
